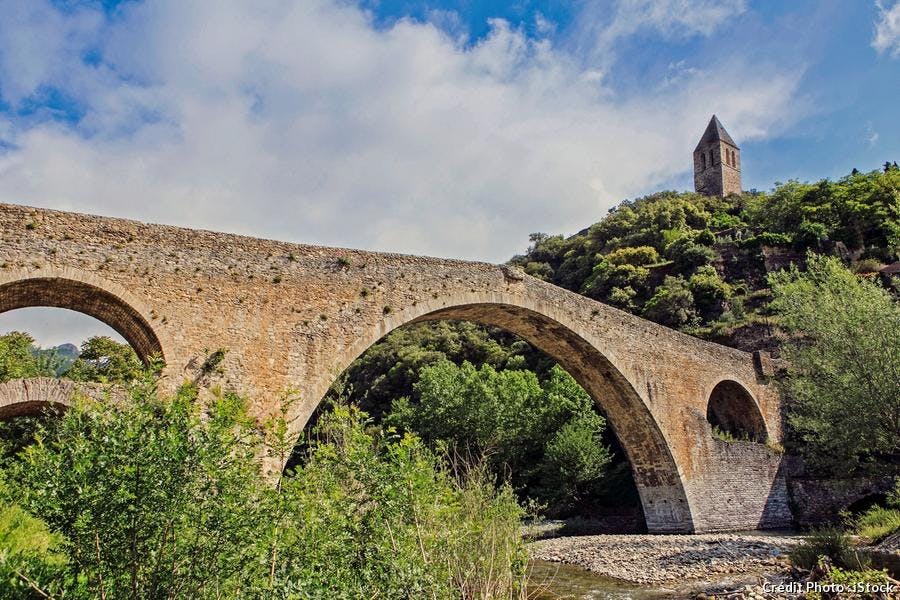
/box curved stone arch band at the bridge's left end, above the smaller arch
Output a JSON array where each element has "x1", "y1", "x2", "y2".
[{"x1": 0, "y1": 268, "x2": 165, "y2": 361}]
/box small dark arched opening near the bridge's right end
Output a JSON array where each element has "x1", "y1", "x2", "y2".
[{"x1": 706, "y1": 380, "x2": 767, "y2": 443}]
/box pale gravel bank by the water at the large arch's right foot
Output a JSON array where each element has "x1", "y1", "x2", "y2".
[{"x1": 529, "y1": 534, "x2": 800, "y2": 584}]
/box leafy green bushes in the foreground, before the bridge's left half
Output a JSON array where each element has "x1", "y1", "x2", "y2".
[{"x1": 0, "y1": 376, "x2": 526, "y2": 599}]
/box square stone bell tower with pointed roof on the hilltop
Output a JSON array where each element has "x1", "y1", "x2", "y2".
[{"x1": 694, "y1": 115, "x2": 741, "y2": 196}]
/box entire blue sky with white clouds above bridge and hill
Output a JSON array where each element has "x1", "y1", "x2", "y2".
[{"x1": 0, "y1": 0, "x2": 900, "y2": 343}]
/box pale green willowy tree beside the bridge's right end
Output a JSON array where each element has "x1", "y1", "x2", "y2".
[{"x1": 771, "y1": 255, "x2": 900, "y2": 473}]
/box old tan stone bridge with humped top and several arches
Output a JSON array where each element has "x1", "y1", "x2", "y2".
[{"x1": 0, "y1": 204, "x2": 790, "y2": 532}]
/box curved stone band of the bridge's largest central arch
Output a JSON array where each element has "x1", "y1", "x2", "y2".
[{"x1": 302, "y1": 293, "x2": 695, "y2": 533}]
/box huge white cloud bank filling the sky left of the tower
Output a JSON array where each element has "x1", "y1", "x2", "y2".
[{"x1": 0, "y1": 0, "x2": 802, "y2": 261}]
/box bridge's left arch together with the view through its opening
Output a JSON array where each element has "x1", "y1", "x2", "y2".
[{"x1": 0, "y1": 275, "x2": 162, "y2": 432}]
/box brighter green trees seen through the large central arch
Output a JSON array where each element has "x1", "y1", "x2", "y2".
[{"x1": 384, "y1": 361, "x2": 612, "y2": 510}]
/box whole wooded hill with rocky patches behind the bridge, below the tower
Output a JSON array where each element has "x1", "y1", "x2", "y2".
[{"x1": 511, "y1": 163, "x2": 900, "y2": 350}]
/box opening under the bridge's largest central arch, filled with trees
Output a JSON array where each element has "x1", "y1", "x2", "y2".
[{"x1": 304, "y1": 320, "x2": 646, "y2": 534}]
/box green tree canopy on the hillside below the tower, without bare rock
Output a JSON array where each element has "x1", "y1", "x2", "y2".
[{"x1": 511, "y1": 168, "x2": 900, "y2": 333}]
